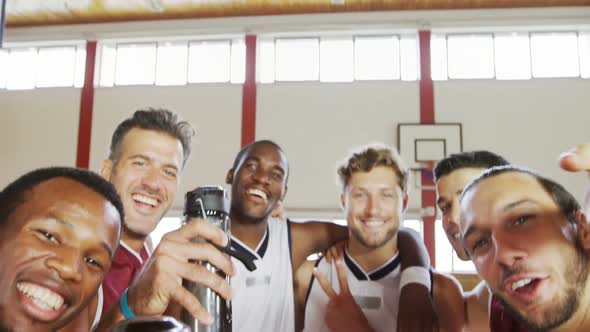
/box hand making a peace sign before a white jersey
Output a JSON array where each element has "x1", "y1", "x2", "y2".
[{"x1": 312, "y1": 258, "x2": 373, "y2": 332}]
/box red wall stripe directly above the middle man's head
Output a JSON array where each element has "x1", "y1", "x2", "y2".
[{"x1": 242, "y1": 35, "x2": 256, "y2": 146}]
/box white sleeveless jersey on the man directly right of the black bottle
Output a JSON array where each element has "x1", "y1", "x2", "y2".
[{"x1": 231, "y1": 218, "x2": 295, "y2": 332}]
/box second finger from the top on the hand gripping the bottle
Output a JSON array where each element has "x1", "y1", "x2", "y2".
[{"x1": 154, "y1": 239, "x2": 235, "y2": 275}]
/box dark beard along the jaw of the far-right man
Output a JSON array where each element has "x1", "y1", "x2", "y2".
[{"x1": 498, "y1": 241, "x2": 589, "y2": 332}]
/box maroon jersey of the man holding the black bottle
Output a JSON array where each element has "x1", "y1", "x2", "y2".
[{"x1": 102, "y1": 241, "x2": 149, "y2": 315}]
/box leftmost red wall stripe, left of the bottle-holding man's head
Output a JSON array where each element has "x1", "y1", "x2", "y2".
[{"x1": 76, "y1": 40, "x2": 96, "y2": 168}]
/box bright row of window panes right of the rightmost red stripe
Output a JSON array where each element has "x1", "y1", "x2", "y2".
[{"x1": 430, "y1": 31, "x2": 590, "y2": 80}]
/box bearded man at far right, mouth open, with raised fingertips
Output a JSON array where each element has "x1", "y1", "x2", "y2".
[{"x1": 460, "y1": 144, "x2": 590, "y2": 331}]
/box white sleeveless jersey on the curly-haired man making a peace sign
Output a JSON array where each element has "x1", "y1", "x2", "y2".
[{"x1": 304, "y1": 250, "x2": 401, "y2": 332}]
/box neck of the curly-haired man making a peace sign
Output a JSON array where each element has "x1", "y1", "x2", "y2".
[{"x1": 348, "y1": 234, "x2": 397, "y2": 272}]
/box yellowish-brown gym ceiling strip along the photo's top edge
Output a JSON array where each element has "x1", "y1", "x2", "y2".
[{"x1": 6, "y1": 0, "x2": 590, "y2": 27}]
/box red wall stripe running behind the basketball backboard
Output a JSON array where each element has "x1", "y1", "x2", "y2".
[{"x1": 418, "y1": 31, "x2": 436, "y2": 267}]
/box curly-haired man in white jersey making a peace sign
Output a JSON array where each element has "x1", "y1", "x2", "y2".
[{"x1": 296, "y1": 145, "x2": 464, "y2": 331}]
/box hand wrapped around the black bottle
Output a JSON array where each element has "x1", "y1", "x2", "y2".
[{"x1": 128, "y1": 219, "x2": 234, "y2": 324}]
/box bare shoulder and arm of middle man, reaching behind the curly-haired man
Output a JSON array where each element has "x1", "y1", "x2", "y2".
[{"x1": 291, "y1": 221, "x2": 348, "y2": 271}]
